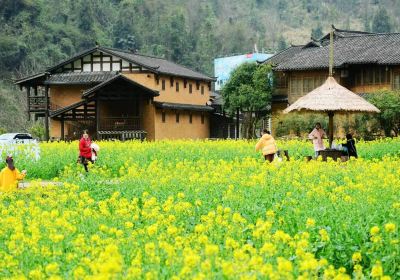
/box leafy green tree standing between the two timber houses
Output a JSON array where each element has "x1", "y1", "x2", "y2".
[{"x1": 222, "y1": 63, "x2": 272, "y2": 139}]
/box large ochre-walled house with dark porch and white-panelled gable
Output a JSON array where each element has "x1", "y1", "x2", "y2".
[{"x1": 16, "y1": 46, "x2": 214, "y2": 140}]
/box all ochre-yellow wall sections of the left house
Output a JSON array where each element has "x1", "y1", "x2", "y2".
[{"x1": 50, "y1": 73, "x2": 210, "y2": 140}]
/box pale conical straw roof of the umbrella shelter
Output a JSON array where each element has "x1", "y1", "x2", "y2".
[{"x1": 283, "y1": 77, "x2": 380, "y2": 113}]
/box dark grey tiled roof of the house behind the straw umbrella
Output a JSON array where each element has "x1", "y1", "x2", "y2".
[{"x1": 266, "y1": 29, "x2": 400, "y2": 71}]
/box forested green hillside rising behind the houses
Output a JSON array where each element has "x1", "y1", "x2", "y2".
[{"x1": 0, "y1": 0, "x2": 400, "y2": 129}]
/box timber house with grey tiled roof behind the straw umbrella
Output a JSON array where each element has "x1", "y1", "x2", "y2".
[{"x1": 264, "y1": 26, "x2": 400, "y2": 128}]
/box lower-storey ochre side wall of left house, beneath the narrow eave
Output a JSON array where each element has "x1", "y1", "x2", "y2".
[{"x1": 155, "y1": 109, "x2": 210, "y2": 140}]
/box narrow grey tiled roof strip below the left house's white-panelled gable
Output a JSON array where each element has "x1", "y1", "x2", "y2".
[{"x1": 44, "y1": 72, "x2": 117, "y2": 85}]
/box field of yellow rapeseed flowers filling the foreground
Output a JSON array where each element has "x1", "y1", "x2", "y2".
[{"x1": 0, "y1": 139, "x2": 400, "y2": 279}]
